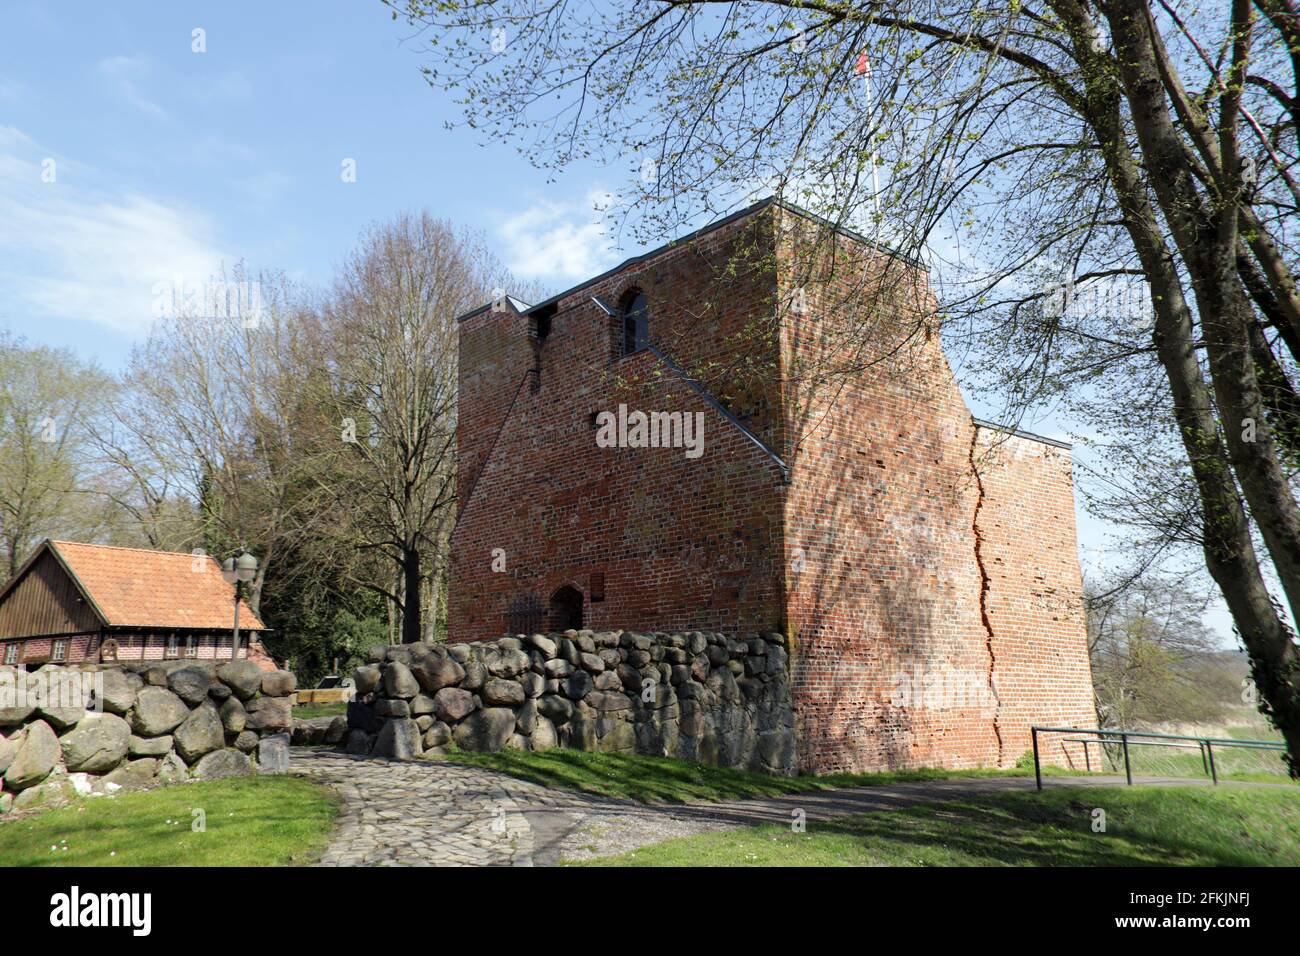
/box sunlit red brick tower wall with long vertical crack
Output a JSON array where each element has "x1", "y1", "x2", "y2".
[{"x1": 781, "y1": 205, "x2": 1095, "y2": 773}]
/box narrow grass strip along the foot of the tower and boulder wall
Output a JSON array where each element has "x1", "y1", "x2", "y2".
[{"x1": 437, "y1": 749, "x2": 1034, "y2": 804}]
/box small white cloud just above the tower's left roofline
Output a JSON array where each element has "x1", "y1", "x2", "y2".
[{"x1": 497, "y1": 191, "x2": 614, "y2": 282}]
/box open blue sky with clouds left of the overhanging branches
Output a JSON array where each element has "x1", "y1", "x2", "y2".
[{"x1": 0, "y1": 0, "x2": 1229, "y2": 637}]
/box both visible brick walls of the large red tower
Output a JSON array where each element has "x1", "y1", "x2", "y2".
[{"x1": 449, "y1": 200, "x2": 1095, "y2": 771}]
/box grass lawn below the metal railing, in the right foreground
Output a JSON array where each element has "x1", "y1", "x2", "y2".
[{"x1": 584, "y1": 787, "x2": 1300, "y2": 866}]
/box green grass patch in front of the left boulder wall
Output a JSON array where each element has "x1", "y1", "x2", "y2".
[{"x1": 0, "y1": 777, "x2": 337, "y2": 866}]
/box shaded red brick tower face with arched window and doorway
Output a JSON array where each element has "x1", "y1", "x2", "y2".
[{"x1": 449, "y1": 216, "x2": 781, "y2": 641}]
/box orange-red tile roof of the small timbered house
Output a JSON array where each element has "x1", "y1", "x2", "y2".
[{"x1": 49, "y1": 541, "x2": 267, "y2": 631}]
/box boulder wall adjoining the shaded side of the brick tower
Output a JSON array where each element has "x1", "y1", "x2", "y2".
[{"x1": 346, "y1": 631, "x2": 796, "y2": 774}]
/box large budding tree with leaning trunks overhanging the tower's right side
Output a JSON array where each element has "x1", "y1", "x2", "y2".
[{"x1": 390, "y1": 0, "x2": 1300, "y2": 774}]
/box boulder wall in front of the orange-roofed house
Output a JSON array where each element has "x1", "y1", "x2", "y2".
[{"x1": 0, "y1": 661, "x2": 297, "y2": 813}]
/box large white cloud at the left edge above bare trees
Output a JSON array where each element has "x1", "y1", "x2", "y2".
[{"x1": 0, "y1": 127, "x2": 230, "y2": 334}]
